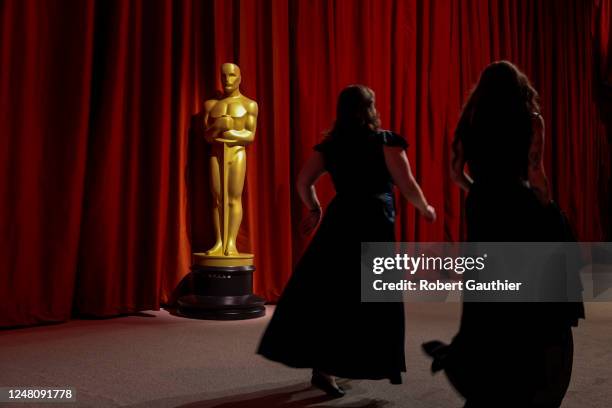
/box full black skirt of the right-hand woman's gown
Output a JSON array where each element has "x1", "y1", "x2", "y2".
[{"x1": 424, "y1": 178, "x2": 584, "y2": 408}]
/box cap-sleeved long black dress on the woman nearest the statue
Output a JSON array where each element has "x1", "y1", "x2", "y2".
[{"x1": 258, "y1": 131, "x2": 407, "y2": 384}]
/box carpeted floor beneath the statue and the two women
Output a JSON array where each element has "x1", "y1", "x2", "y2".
[{"x1": 0, "y1": 303, "x2": 612, "y2": 408}]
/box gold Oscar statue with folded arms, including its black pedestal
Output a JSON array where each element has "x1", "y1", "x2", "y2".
[{"x1": 178, "y1": 63, "x2": 265, "y2": 320}]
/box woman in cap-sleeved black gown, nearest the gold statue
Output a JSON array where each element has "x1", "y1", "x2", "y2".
[{"x1": 258, "y1": 85, "x2": 436, "y2": 397}]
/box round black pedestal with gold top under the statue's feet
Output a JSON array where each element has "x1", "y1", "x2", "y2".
[{"x1": 178, "y1": 253, "x2": 266, "y2": 320}]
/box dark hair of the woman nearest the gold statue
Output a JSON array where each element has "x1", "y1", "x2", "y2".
[{"x1": 327, "y1": 85, "x2": 380, "y2": 139}]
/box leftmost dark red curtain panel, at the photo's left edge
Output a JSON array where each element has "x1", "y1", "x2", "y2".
[{"x1": 0, "y1": 0, "x2": 94, "y2": 326}]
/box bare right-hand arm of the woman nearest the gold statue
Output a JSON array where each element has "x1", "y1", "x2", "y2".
[{"x1": 384, "y1": 146, "x2": 436, "y2": 221}]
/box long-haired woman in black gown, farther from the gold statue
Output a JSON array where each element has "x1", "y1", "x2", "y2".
[{"x1": 423, "y1": 61, "x2": 584, "y2": 408}]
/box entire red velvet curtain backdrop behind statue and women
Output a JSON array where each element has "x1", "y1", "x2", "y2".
[{"x1": 0, "y1": 0, "x2": 612, "y2": 326}]
